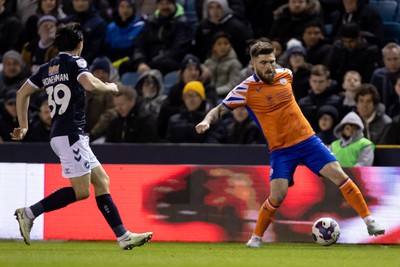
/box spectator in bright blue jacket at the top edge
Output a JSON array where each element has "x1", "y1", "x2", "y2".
[{"x1": 103, "y1": 0, "x2": 145, "y2": 62}]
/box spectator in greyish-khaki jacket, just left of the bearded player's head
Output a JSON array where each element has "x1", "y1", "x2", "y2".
[{"x1": 204, "y1": 32, "x2": 243, "y2": 99}]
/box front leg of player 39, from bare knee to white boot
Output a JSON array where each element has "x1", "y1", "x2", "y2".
[{"x1": 91, "y1": 165, "x2": 153, "y2": 249}]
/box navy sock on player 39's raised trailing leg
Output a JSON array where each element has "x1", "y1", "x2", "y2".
[{"x1": 30, "y1": 187, "x2": 76, "y2": 217}]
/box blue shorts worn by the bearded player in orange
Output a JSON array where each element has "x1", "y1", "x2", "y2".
[{"x1": 269, "y1": 135, "x2": 337, "y2": 186}]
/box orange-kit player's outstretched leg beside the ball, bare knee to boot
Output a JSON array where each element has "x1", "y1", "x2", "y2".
[{"x1": 320, "y1": 161, "x2": 385, "y2": 236}]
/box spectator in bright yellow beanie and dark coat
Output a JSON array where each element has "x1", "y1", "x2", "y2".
[{"x1": 166, "y1": 81, "x2": 226, "y2": 143}]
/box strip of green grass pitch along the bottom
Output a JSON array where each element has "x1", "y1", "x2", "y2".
[{"x1": 0, "y1": 240, "x2": 400, "y2": 267}]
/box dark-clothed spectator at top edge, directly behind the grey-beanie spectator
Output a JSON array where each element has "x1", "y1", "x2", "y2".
[{"x1": 23, "y1": 0, "x2": 67, "y2": 44}]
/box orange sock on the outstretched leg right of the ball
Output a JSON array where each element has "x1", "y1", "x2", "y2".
[{"x1": 339, "y1": 178, "x2": 371, "y2": 219}]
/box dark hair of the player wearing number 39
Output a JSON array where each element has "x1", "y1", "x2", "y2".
[{"x1": 54, "y1": 22, "x2": 83, "y2": 51}]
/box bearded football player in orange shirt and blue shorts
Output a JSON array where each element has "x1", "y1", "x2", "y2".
[{"x1": 196, "y1": 42, "x2": 385, "y2": 248}]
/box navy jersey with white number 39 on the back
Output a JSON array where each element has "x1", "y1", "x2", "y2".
[{"x1": 28, "y1": 52, "x2": 89, "y2": 138}]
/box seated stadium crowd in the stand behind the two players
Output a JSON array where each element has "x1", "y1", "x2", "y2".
[{"x1": 0, "y1": 0, "x2": 400, "y2": 152}]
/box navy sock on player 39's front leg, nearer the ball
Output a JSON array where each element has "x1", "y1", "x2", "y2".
[{"x1": 96, "y1": 194, "x2": 127, "y2": 237}]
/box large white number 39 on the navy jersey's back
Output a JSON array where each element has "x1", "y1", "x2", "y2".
[{"x1": 46, "y1": 83, "x2": 71, "y2": 118}]
